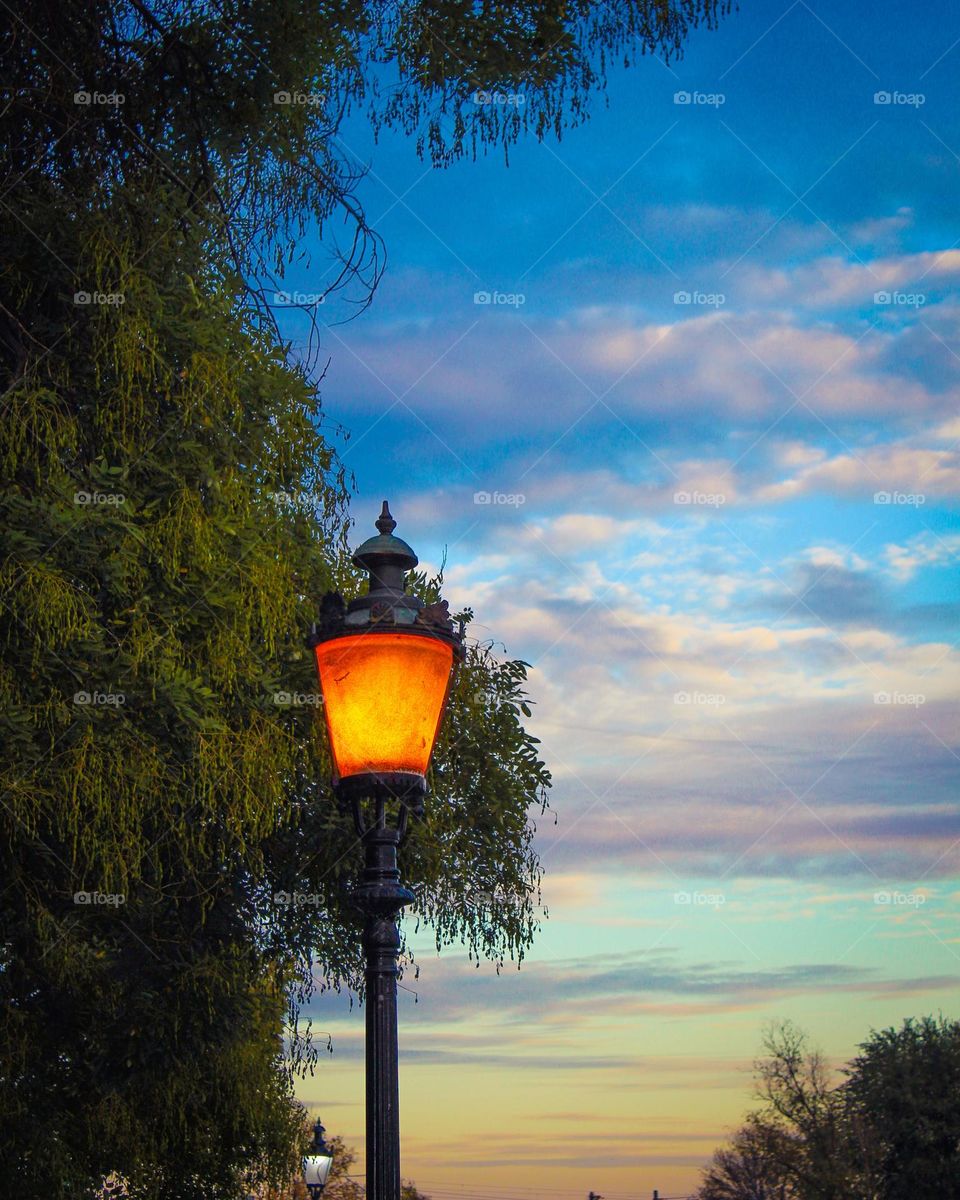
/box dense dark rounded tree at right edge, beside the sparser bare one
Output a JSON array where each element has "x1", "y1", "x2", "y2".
[{"x1": 844, "y1": 1015, "x2": 960, "y2": 1200}]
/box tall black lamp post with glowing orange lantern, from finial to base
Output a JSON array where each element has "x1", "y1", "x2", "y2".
[{"x1": 307, "y1": 500, "x2": 463, "y2": 1200}]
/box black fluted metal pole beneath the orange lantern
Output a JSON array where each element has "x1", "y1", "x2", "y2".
[{"x1": 354, "y1": 799, "x2": 415, "y2": 1200}]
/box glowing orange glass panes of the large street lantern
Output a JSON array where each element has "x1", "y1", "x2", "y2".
[{"x1": 316, "y1": 631, "x2": 454, "y2": 779}]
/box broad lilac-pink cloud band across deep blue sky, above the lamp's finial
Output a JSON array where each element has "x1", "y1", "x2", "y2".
[{"x1": 330, "y1": 276, "x2": 960, "y2": 464}]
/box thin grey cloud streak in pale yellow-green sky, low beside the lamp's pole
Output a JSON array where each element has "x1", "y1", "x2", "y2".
[{"x1": 311, "y1": 940, "x2": 960, "y2": 1036}]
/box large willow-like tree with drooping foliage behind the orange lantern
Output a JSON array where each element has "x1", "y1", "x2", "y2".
[{"x1": 0, "y1": 0, "x2": 719, "y2": 1200}]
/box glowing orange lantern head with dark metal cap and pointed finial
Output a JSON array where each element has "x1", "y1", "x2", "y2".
[{"x1": 310, "y1": 500, "x2": 462, "y2": 798}]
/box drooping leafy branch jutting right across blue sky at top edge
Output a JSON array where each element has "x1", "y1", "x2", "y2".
[{"x1": 365, "y1": 0, "x2": 731, "y2": 166}]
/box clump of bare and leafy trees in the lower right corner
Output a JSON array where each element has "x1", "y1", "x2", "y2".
[{"x1": 697, "y1": 1016, "x2": 960, "y2": 1200}]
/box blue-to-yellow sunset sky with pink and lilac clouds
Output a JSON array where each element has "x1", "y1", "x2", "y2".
[{"x1": 283, "y1": 0, "x2": 960, "y2": 1200}]
